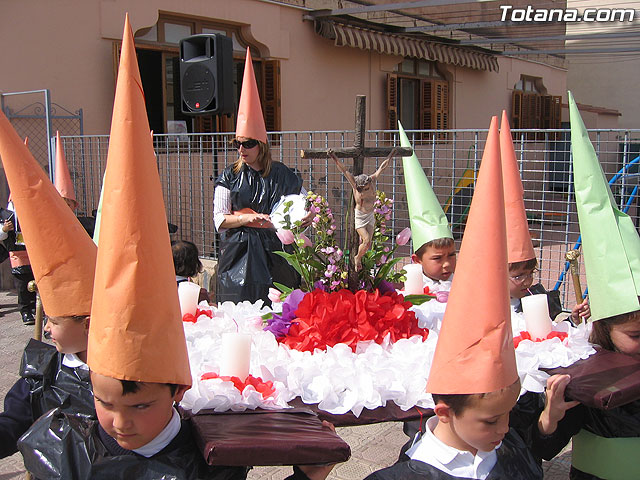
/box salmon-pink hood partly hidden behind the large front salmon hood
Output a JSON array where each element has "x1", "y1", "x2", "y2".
[{"x1": 500, "y1": 110, "x2": 536, "y2": 263}]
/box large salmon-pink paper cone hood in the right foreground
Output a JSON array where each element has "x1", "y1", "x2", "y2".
[{"x1": 427, "y1": 117, "x2": 518, "y2": 394}]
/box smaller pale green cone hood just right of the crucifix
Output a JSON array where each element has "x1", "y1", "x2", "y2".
[{"x1": 398, "y1": 122, "x2": 453, "y2": 252}]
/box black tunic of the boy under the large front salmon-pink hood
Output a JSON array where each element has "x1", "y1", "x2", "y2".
[{"x1": 366, "y1": 429, "x2": 542, "y2": 480}]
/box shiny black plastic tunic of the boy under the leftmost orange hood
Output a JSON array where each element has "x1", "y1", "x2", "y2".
[{"x1": 0, "y1": 339, "x2": 94, "y2": 458}]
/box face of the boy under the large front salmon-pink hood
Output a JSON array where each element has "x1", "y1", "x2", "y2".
[{"x1": 434, "y1": 382, "x2": 520, "y2": 455}]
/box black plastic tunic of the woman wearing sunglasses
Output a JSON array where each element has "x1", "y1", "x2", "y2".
[{"x1": 216, "y1": 162, "x2": 302, "y2": 303}]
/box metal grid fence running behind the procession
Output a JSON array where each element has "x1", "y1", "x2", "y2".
[{"x1": 63, "y1": 130, "x2": 640, "y2": 307}]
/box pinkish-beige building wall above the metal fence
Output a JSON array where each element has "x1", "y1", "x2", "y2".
[{"x1": 0, "y1": 0, "x2": 566, "y2": 134}]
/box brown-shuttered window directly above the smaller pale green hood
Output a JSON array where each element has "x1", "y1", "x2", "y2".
[{"x1": 386, "y1": 59, "x2": 450, "y2": 138}]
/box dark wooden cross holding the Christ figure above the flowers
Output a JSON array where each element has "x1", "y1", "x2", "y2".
[{"x1": 300, "y1": 95, "x2": 413, "y2": 291}]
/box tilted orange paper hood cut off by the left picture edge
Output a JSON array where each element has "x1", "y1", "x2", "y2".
[{"x1": 0, "y1": 112, "x2": 97, "y2": 317}]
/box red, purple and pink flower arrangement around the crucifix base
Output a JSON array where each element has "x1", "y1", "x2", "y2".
[{"x1": 264, "y1": 191, "x2": 429, "y2": 352}]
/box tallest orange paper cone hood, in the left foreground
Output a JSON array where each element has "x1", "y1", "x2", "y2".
[{"x1": 87, "y1": 15, "x2": 191, "y2": 385}]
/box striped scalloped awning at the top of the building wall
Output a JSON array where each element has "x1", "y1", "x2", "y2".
[{"x1": 315, "y1": 20, "x2": 498, "y2": 72}]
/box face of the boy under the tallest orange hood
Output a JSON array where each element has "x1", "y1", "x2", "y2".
[{"x1": 91, "y1": 372, "x2": 188, "y2": 450}]
